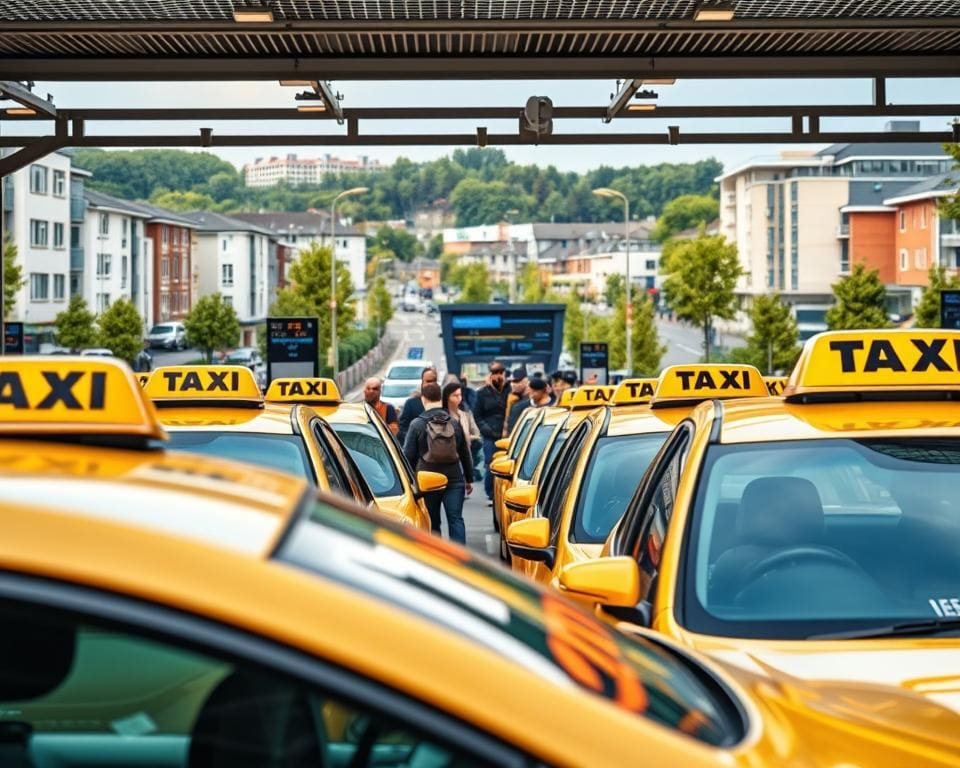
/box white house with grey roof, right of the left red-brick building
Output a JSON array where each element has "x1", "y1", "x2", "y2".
[{"x1": 183, "y1": 211, "x2": 277, "y2": 347}]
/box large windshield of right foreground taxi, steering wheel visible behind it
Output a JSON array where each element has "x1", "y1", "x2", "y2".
[{"x1": 684, "y1": 437, "x2": 960, "y2": 639}]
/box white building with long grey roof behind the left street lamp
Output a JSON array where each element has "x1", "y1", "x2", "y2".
[{"x1": 233, "y1": 210, "x2": 367, "y2": 293}]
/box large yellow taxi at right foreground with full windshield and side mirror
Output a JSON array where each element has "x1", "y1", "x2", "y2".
[{"x1": 559, "y1": 330, "x2": 960, "y2": 765}]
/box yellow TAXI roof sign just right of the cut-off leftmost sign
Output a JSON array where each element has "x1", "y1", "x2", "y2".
[{"x1": 143, "y1": 365, "x2": 263, "y2": 408}]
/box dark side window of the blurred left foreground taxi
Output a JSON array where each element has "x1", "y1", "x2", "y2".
[{"x1": 0, "y1": 600, "x2": 506, "y2": 766}]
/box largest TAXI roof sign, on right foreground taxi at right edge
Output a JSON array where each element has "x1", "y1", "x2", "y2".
[{"x1": 783, "y1": 329, "x2": 960, "y2": 402}]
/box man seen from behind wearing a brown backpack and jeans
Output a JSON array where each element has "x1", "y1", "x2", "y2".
[{"x1": 403, "y1": 382, "x2": 473, "y2": 544}]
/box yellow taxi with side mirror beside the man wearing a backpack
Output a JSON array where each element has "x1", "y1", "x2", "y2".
[{"x1": 264, "y1": 378, "x2": 447, "y2": 531}]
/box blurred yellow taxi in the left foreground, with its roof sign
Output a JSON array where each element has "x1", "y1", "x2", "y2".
[{"x1": 0, "y1": 357, "x2": 772, "y2": 768}]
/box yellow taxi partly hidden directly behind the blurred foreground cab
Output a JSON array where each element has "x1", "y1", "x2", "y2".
[{"x1": 143, "y1": 365, "x2": 374, "y2": 505}]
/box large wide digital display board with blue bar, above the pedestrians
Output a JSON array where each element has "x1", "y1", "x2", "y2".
[{"x1": 440, "y1": 304, "x2": 564, "y2": 370}]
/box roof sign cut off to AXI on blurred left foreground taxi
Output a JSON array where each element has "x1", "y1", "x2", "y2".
[{"x1": 0, "y1": 355, "x2": 166, "y2": 440}]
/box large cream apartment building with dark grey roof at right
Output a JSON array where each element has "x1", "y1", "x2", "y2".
[{"x1": 717, "y1": 124, "x2": 951, "y2": 338}]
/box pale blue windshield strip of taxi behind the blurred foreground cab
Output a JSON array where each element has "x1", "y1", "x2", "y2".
[{"x1": 164, "y1": 430, "x2": 313, "y2": 481}]
